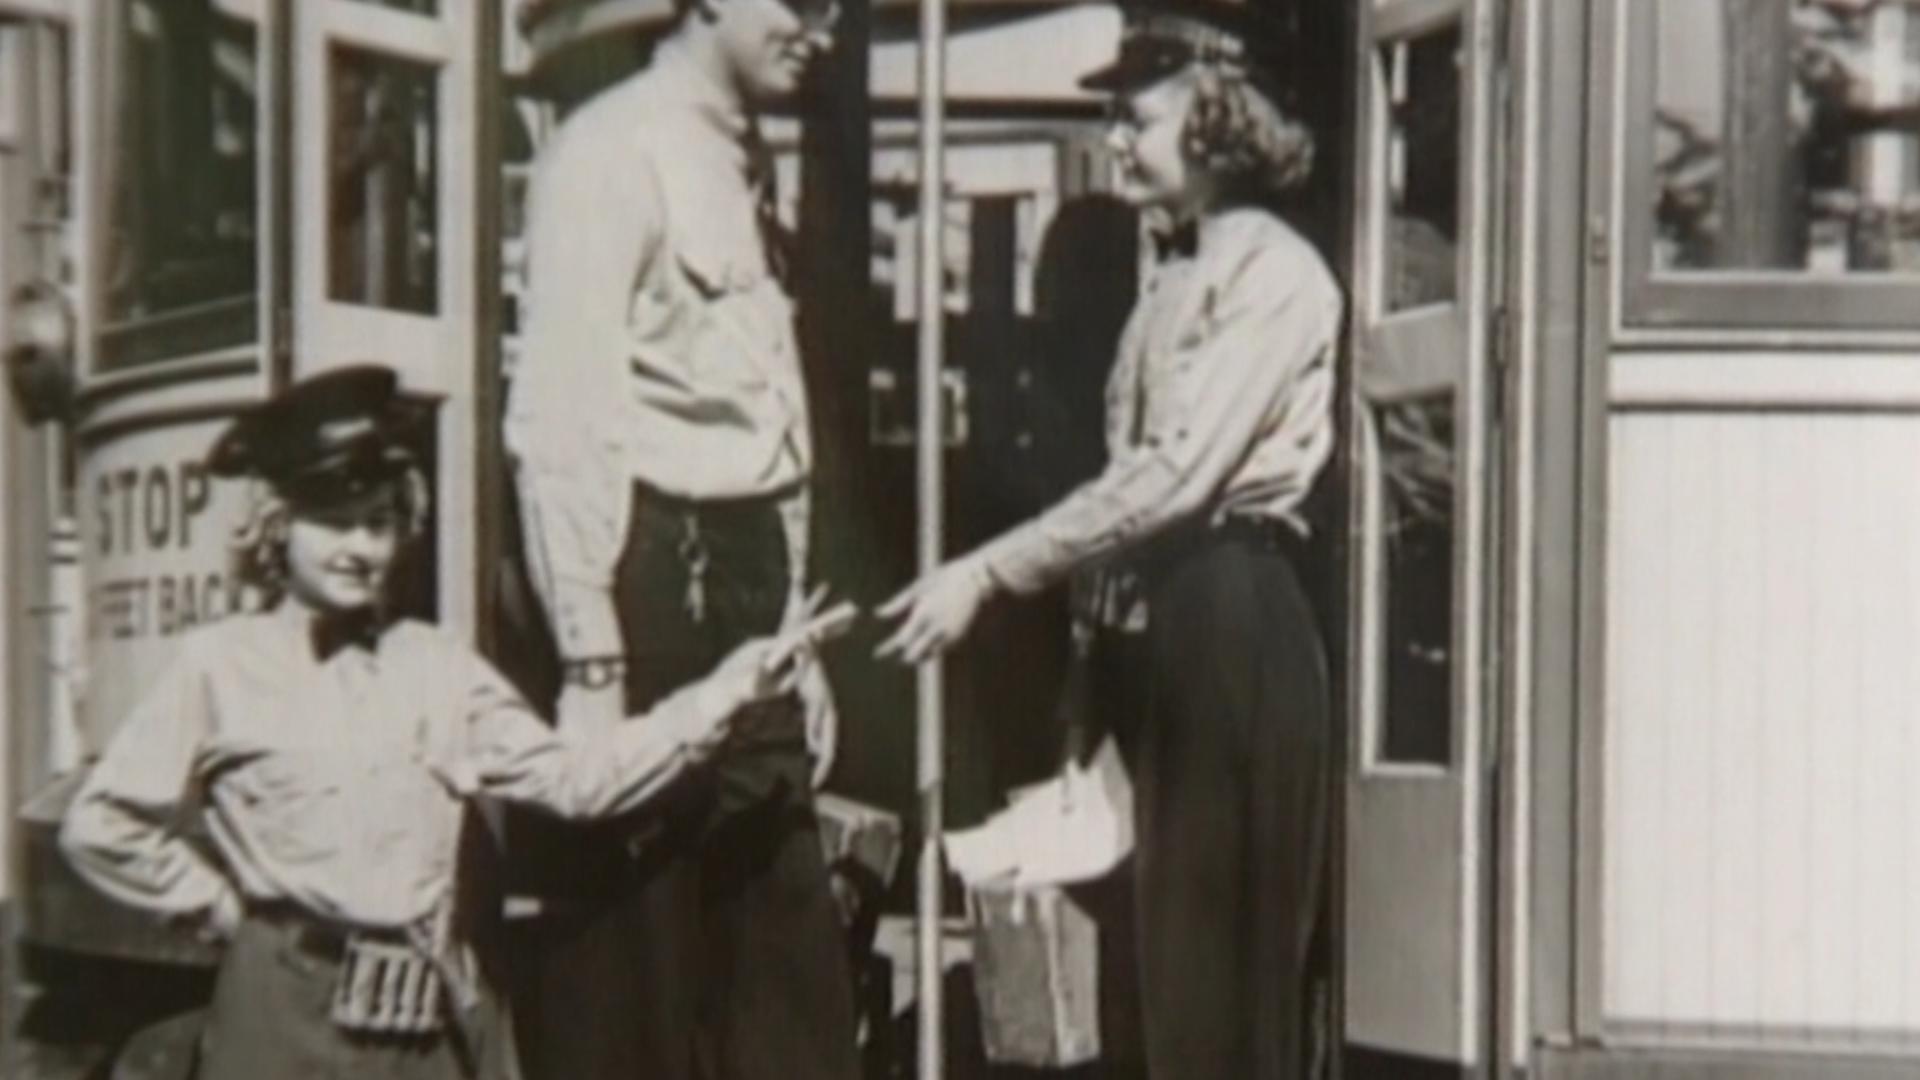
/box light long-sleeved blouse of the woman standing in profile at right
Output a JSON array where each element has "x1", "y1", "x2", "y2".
[{"x1": 979, "y1": 201, "x2": 1342, "y2": 592}]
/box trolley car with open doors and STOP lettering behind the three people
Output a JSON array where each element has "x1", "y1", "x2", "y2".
[{"x1": 0, "y1": 0, "x2": 1920, "y2": 1078}]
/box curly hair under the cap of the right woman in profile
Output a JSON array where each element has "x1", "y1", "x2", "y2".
[{"x1": 1181, "y1": 58, "x2": 1313, "y2": 202}]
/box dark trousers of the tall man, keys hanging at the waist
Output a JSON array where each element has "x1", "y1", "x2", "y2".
[{"x1": 516, "y1": 488, "x2": 858, "y2": 1080}]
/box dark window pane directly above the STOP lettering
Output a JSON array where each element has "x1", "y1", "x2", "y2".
[{"x1": 104, "y1": 0, "x2": 259, "y2": 330}]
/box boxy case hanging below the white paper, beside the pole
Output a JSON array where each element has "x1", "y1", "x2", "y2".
[{"x1": 968, "y1": 886, "x2": 1100, "y2": 1068}]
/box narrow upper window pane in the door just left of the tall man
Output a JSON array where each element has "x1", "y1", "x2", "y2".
[{"x1": 326, "y1": 46, "x2": 440, "y2": 315}]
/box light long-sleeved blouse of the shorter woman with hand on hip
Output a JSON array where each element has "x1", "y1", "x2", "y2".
[{"x1": 60, "y1": 601, "x2": 708, "y2": 928}]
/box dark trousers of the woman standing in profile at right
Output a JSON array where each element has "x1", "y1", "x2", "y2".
[{"x1": 1096, "y1": 532, "x2": 1332, "y2": 1080}]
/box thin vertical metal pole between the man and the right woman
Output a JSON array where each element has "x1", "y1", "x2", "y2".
[{"x1": 916, "y1": 0, "x2": 947, "y2": 1080}]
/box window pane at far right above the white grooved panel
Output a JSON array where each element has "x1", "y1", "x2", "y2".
[{"x1": 1645, "y1": 0, "x2": 1920, "y2": 275}]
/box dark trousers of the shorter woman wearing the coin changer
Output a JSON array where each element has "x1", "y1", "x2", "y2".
[{"x1": 194, "y1": 917, "x2": 505, "y2": 1080}]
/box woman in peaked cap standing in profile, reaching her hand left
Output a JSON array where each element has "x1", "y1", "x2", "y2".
[{"x1": 881, "y1": 4, "x2": 1342, "y2": 1080}]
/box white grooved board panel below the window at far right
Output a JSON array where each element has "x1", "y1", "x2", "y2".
[{"x1": 1601, "y1": 409, "x2": 1920, "y2": 1043}]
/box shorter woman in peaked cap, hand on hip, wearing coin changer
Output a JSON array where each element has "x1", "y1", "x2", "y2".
[{"x1": 61, "y1": 367, "x2": 810, "y2": 1080}]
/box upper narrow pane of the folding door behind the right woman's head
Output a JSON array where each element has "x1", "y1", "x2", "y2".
[{"x1": 1380, "y1": 25, "x2": 1461, "y2": 311}]
